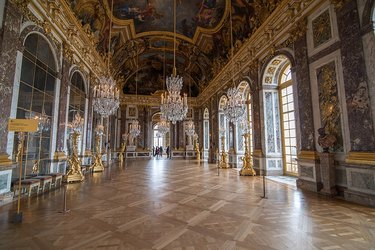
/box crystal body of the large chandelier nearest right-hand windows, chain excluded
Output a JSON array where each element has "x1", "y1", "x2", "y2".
[{"x1": 223, "y1": 88, "x2": 245, "y2": 123}]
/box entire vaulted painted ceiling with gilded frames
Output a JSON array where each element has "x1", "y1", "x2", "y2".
[{"x1": 67, "y1": 0, "x2": 281, "y2": 96}]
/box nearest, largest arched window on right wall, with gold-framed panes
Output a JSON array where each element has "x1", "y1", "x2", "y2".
[{"x1": 263, "y1": 55, "x2": 298, "y2": 175}]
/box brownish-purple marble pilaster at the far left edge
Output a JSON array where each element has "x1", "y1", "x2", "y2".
[{"x1": 0, "y1": 3, "x2": 22, "y2": 152}]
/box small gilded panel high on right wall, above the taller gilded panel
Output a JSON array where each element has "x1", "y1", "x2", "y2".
[{"x1": 312, "y1": 9, "x2": 332, "y2": 48}]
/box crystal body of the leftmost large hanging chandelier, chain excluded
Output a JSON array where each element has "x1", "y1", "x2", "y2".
[{"x1": 93, "y1": 76, "x2": 120, "y2": 117}]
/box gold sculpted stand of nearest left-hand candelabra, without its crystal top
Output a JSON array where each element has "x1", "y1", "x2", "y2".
[{"x1": 64, "y1": 131, "x2": 85, "y2": 183}]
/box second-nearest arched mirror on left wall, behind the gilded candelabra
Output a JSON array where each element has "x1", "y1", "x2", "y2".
[{"x1": 68, "y1": 71, "x2": 86, "y2": 153}]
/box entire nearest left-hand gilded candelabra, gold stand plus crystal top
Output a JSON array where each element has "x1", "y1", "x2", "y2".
[{"x1": 64, "y1": 113, "x2": 85, "y2": 183}]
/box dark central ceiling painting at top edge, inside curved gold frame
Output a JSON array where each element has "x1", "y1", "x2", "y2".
[{"x1": 112, "y1": 0, "x2": 225, "y2": 39}]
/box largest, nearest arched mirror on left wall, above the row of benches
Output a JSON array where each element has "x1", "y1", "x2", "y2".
[{"x1": 14, "y1": 33, "x2": 57, "y2": 175}]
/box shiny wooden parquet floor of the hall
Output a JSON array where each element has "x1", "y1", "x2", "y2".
[{"x1": 0, "y1": 159, "x2": 375, "y2": 250}]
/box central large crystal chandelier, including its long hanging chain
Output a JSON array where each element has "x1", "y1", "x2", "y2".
[{"x1": 160, "y1": 0, "x2": 188, "y2": 124}]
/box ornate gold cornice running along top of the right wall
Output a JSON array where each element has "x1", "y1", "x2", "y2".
[{"x1": 198, "y1": 0, "x2": 326, "y2": 103}]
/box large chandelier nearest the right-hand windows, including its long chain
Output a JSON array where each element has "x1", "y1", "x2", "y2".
[{"x1": 223, "y1": 1, "x2": 245, "y2": 123}]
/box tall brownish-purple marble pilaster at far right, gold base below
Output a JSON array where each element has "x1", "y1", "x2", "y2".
[{"x1": 337, "y1": 0, "x2": 375, "y2": 151}]
